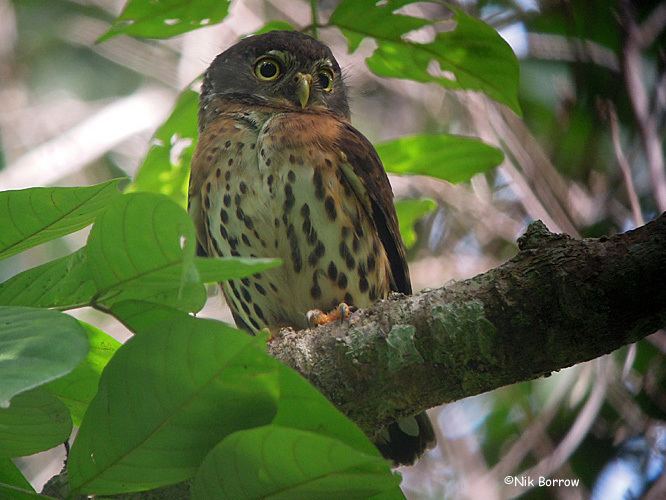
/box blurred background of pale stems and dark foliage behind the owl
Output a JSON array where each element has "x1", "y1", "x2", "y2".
[{"x1": 0, "y1": 0, "x2": 666, "y2": 499}]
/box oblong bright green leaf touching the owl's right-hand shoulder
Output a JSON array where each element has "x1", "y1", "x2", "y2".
[{"x1": 377, "y1": 134, "x2": 504, "y2": 183}]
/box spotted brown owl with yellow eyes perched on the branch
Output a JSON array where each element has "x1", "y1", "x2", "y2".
[{"x1": 188, "y1": 31, "x2": 434, "y2": 464}]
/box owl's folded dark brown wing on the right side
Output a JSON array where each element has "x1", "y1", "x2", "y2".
[{"x1": 336, "y1": 122, "x2": 412, "y2": 295}]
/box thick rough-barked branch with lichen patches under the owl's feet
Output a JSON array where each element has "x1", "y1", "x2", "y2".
[{"x1": 270, "y1": 213, "x2": 666, "y2": 435}]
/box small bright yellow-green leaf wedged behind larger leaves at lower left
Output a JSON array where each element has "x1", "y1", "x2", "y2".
[{"x1": 46, "y1": 322, "x2": 122, "y2": 426}]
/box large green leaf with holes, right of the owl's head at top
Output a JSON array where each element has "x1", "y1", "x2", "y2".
[{"x1": 330, "y1": 0, "x2": 520, "y2": 114}]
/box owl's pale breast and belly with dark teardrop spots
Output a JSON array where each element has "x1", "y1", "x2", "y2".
[{"x1": 195, "y1": 113, "x2": 391, "y2": 331}]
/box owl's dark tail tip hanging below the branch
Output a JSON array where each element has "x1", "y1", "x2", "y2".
[{"x1": 375, "y1": 412, "x2": 437, "y2": 465}]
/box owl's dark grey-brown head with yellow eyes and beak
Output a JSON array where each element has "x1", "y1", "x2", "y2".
[{"x1": 201, "y1": 31, "x2": 349, "y2": 125}]
